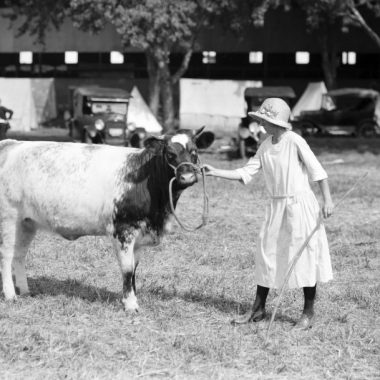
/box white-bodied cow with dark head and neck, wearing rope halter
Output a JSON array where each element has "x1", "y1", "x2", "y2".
[{"x1": 0, "y1": 128, "x2": 213, "y2": 311}]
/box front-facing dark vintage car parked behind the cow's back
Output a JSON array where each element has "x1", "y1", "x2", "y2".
[{"x1": 69, "y1": 86, "x2": 146, "y2": 147}]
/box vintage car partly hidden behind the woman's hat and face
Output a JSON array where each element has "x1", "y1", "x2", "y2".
[{"x1": 237, "y1": 86, "x2": 296, "y2": 158}]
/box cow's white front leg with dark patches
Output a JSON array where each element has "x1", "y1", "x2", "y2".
[{"x1": 114, "y1": 230, "x2": 139, "y2": 312}]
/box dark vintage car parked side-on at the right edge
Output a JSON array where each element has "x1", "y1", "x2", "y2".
[{"x1": 292, "y1": 88, "x2": 380, "y2": 137}]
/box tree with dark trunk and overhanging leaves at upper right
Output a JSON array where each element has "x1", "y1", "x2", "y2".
[{"x1": 252, "y1": 0, "x2": 380, "y2": 89}]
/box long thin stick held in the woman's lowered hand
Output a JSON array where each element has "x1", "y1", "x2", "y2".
[{"x1": 264, "y1": 172, "x2": 369, "y2": 344}]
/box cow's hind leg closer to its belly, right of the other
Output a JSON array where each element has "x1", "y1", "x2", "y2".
[{"x1": 13, "y1": 220, "x2": 36, "y2": 295}]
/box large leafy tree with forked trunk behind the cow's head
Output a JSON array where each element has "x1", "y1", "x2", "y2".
[{"x1": 4, "y1": 0, "x2": 236, "y2": 129}]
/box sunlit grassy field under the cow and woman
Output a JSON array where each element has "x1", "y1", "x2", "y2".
[{"x1": 0, "y1": 143, "x2": 380, "y2": 379}]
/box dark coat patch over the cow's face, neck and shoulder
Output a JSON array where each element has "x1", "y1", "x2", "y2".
[{"x1": 113, "y1": 128, "x2": 211, "y2": 243}]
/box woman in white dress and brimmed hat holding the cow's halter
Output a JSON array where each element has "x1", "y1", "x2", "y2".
[{"x1": 204, "y1": 98, "x2": 333, "y2": 329}]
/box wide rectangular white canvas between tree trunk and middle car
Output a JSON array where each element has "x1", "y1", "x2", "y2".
[{"x1": 179, "y1": 78, "x2": 262, "y2": 132}]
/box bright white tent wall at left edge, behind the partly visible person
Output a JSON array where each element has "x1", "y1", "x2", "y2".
[{"x1": 0, "y1": 78, "x2": 38, "y2": 132}]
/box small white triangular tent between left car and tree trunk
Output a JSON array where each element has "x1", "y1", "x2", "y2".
[{"x1": 128, "y1": 86, "x2": 162, "y2": 133}]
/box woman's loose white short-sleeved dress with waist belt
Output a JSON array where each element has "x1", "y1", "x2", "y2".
[{"x1": 237, "y1": 131, "x2": 332, "y2": 288}]
